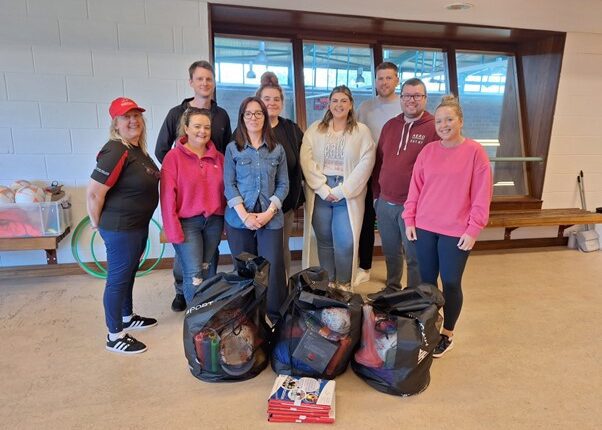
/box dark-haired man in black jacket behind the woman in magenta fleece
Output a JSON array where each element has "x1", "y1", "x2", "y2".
[{"x1": 155, "y1": 60, "x2": 232, "y2": 312}]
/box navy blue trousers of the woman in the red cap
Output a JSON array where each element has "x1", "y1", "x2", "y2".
[{"x1": 98, "y1": 227, "x2": 148, "y2": 333}]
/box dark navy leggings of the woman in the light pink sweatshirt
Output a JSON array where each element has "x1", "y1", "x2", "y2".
[{"x1": 416, "y1": 228, "x2": 470, "y2": 331}]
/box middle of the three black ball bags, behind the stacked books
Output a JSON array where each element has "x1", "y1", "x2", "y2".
[{"x1": 272, "y1": 267, "x2": 363, "y2": 379}]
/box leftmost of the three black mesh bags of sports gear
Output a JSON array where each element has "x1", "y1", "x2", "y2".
[{"x1": 184, "y1": 253, "x2": 270, "y2": 382}]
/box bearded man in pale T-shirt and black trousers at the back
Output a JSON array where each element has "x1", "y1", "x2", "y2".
[{"x1": 356, "y1": 61, "x2": 401, "y2": 284}]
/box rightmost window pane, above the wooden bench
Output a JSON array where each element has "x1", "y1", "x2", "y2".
[{"x1": 456, "y1": 51, "x2": 528, "y2": 195}]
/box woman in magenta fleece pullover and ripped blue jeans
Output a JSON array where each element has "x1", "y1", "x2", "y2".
[{"x1": 161, "y1": 107, "x2": 226, "y2": 305}]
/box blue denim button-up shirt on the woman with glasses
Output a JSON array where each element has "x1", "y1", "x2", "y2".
[{"x1": 224, "y1": 142, "x2": 288, "y2": 229}]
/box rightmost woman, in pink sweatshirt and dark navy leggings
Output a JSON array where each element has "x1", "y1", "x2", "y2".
[{"x1": 402, "y1": 96, "x2": 492, "y2": 358}]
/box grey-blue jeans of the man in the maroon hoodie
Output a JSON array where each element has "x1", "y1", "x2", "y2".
[{"x1": 376, "y1": 199, "x2": 420, "y2": 289}]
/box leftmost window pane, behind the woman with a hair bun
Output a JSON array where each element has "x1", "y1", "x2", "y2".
[{"x1": 214, "y1": 36, "x2": 295, "y2": 130}]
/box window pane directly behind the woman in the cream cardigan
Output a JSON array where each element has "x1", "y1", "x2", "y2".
[{"x1": 303, "y1": 43, "x2": 374, "y2": 126}]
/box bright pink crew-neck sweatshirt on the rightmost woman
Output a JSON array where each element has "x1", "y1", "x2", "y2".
[{"x1": 402, "y1": 139, "x2": 493, "y2": 239}]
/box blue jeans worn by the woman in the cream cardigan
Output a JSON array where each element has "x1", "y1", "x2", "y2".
[{"x1": 311, "y1": 176, "x2": 353, "y2": 283}]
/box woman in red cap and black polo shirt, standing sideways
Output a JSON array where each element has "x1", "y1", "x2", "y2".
[{"x1": 86, "y1": 97, "x2": 160, "y2": 354}]
